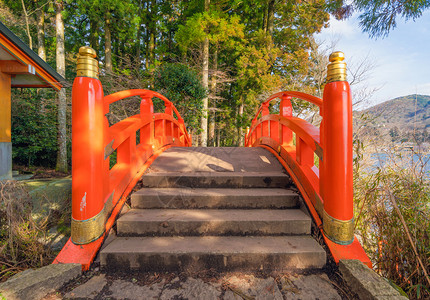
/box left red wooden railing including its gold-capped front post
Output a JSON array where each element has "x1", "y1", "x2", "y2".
[{"x1": 54, "y1": 48, "x2": 191, "y2": 270}]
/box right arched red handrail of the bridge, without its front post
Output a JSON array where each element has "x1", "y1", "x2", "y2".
[{"x1": 245, "y1": 91, "x2": 323, "y2": 229}]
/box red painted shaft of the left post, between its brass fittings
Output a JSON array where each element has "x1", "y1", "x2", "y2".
[{"x1": 72, "y1": 77, "x2": 108, "y2": 220}]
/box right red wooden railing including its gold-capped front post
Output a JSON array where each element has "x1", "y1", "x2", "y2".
[{"x1": 245, "y1": 53, "x2": 371, "y2": 266}]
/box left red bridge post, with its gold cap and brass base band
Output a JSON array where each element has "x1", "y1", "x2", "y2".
[{"x1": 71, "y1": 47, "x2": 109, "y2": 244}]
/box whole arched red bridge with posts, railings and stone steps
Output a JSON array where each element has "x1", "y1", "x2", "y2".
[{"x1": 54, "y1": 47, "x2": 371, "y2": 271}]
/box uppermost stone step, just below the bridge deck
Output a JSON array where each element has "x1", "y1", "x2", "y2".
[{"x1": 142, "y1": 172, "x2": 292, "y2": 188}]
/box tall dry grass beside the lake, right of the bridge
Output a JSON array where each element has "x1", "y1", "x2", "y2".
[{"x1": 354, "y1": 145, "x2": 430, "y2": 299}]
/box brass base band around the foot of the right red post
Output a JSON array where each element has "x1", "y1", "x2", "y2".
[{"x1": 323, "y1": 210, "x2": 354, "y2": 245}]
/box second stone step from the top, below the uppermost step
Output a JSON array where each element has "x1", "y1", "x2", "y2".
[{"x1": 131, "y1": 188, "x2": 299, "y2": 208}]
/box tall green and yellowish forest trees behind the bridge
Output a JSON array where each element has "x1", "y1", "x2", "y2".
[{"x1": 0, "y1": 0, "x2": 341, "y2": 171}]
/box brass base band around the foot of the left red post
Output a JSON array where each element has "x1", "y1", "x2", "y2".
[{"x1": 71, "y1": 191, "x2": 115, "y2": 245}]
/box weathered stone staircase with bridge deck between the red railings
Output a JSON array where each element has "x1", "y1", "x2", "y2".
[{"x1": 100, "y1": 147, "x2": 326, "y2": 272}]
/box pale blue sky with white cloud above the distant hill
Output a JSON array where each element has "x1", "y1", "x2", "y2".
[{"x1": 315, "y1": 11, "x2": 430, "y2": 106}]
